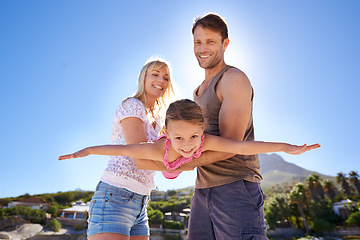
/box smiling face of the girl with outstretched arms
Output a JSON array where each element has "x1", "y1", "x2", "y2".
[{"x1": 166, "y1": 120, "x2": 204, "y2": 157}]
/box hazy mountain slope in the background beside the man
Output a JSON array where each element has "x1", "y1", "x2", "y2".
[{"x1": 259, "y1": 154, "x2": 336, "y2": 191}]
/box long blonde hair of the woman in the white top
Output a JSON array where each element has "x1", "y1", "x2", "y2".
[{"x1": 134, "y1": 57, "x2": 175, "y2": 115}]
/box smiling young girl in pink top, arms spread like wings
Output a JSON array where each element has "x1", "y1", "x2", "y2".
[{"x1": 59, "y1": 99, "x2": 320, "y2": 179}]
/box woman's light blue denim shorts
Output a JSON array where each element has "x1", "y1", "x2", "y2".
[{"x1": 87, "y1": 182, "x2": 149, "y2": 237}]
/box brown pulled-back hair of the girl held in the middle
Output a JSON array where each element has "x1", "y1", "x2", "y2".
[{"x1": 165, "y1": 99, "x2": 205, "y2": 128}]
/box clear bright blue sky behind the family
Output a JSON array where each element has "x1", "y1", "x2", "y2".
[{"x1": 0, "y1": 0, "x2": 360, "y2": 197}]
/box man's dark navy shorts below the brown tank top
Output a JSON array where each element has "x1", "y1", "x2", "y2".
[{"x1": 187, "y1": 180, "x2": 268, "y2": 240}]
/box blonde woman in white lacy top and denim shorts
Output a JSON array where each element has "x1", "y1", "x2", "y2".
[{"x1": 87, "y1": 59, "x2": 174, "y2": 240}]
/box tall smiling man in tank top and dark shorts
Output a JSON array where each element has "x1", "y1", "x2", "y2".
[{"x1": 188, "y1": 14, "x2": 267, "y2": 240}]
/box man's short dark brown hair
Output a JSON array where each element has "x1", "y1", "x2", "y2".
[{"x1": 192, "y1": 13, "x2": 229, "y2": 41}]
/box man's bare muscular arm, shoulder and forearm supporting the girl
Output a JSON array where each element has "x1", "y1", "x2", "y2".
[{"x1": 177, "y1": 69, "x2": 253, "y2": 171}]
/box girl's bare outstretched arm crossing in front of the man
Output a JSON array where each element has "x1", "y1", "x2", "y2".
[{"x1": 204, "y1": 134, "x2": 320, "y2": 155}]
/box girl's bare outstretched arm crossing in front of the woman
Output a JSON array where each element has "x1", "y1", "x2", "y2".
[{"x1": 59, "y1": 142, "x2": 164, "y2": 161}]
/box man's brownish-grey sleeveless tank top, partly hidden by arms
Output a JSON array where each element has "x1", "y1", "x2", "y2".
[{"x1": 194, "y1": 66, "x2": 262, "y2": 188}]
